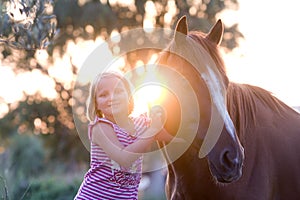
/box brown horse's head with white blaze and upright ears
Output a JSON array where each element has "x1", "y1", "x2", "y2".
[{"x1": 158, "y1": 17, "x2": 244, "y2": 182}]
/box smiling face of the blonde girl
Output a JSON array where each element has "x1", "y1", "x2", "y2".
[{"x1": 96, "y1": 77, "x2": 129, "y2": 118}]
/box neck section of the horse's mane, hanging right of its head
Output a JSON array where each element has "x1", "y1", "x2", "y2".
[{"x1": 227, "y1": 82, "x2": 292, "y2": 141}]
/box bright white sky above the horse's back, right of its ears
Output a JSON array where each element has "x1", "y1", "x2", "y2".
[{"x1": 220, "y1": 0, "x2": 300, "y2": 106}]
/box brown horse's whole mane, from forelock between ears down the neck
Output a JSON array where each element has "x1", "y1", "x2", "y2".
[{"x1": 188, "y1": 31, "x2": 296, "y2": 141}]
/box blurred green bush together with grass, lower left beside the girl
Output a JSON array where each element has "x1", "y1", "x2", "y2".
[{"x1": 0, "y1": 135, "x2": 83, "y2": 199}]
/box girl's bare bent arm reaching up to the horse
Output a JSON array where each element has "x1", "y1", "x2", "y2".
[{"x1": 92, "y1": 113, "x2": 162, "y2": 168}]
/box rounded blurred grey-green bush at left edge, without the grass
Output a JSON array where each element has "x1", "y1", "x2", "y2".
[{"x1": 0, "y1": 134, "x2": 45, "y2": 199}]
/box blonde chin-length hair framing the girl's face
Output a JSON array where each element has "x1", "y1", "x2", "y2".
[{"x1": 86, "y1": 72, "x2": 134, "y2": 122}]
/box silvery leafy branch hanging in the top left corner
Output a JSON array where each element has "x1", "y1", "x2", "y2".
[{"x1": 0, "y1": 0, "x2": 57, "y2": 50}]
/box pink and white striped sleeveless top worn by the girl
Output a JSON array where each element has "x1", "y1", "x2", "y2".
[{"x1": 74, "y1": 115, "x2": 149, "y2": 200}]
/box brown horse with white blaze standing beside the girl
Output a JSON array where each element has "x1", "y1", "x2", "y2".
[{"x1": 157, "y1": 16, "x2": 300, "y2": 200}]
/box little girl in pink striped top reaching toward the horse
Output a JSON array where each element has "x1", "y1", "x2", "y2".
[{"x1": 75, "y1": 72, "x2": 169, "y2": 200}]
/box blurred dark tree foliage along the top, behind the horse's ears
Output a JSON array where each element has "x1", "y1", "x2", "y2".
[{"x1": 50, "y1": 0, "x2": 242, "y2": 53}]
